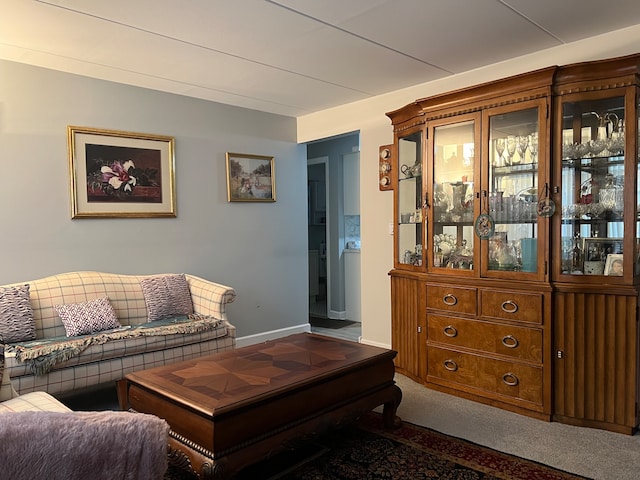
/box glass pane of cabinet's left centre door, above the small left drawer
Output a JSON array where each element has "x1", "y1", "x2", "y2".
[{"x1": 431, "y1": 118, "x2": 478, "y2": 272}]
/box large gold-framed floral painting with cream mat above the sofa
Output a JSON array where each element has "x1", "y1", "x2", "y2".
[{"x1": 67, "y1": 126, "x2": 176, "y2": 218}]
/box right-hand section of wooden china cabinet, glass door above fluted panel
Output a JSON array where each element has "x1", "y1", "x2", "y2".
[{"x1": 552, "y1": 56, "x2": 640, "y2": 433}]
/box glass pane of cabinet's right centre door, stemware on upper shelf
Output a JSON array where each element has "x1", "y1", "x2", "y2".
[{"x1": 482, "y1": 106, "x2": 552, "y2": 275}]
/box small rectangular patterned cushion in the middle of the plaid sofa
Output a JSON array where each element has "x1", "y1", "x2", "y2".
[{"x1": 55, "y1": 297, "x2": 121, "y2": 337}]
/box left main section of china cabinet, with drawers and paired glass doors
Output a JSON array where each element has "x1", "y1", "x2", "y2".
[{"x1": 388, "y1": 68, "x2": 555, "y2": 419}]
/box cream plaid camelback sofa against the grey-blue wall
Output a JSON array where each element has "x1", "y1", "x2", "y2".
[{"x1": 0, "y1": 272, "x2": 236, "y2": 395}]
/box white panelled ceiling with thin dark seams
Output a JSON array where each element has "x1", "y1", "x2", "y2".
[{"x1": 0, "y1": 0, "x2": 640, "y2": 117}]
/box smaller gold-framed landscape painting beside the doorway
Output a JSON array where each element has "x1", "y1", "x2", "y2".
[{"x1": 226, "y1": 152, "x2": 276, "y2": 202}]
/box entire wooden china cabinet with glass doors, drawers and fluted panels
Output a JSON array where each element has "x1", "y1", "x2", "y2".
[{"x1": 387, "y1": 56, "x2": 640, "y2": 433}]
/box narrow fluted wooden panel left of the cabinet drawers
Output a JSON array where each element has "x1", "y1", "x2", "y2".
[{"x1": 391, "y1": 275, "x2": 424, "y2": 382}]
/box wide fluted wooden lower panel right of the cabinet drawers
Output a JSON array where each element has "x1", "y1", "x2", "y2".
[{"x1": 554, "y1": 292, "x2": 638, "y2": 433}]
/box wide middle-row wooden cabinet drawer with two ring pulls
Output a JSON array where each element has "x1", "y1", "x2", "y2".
[{"x1": 427, "y1": 315, "x2": 542, "y2": 363}]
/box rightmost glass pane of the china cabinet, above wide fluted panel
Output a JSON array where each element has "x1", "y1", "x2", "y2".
[{"x1": 556, "y1": 95, "x2": 624, "y2": 281}]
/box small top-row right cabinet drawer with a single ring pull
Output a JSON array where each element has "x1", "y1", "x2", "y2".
[{"x1": 480, "y1": 290, "x2": 543, "y2": 324}]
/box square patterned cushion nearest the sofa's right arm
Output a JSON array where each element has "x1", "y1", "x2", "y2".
[{"x1": 140, "y1": 273, "x2": 193, "y2": 322}]
